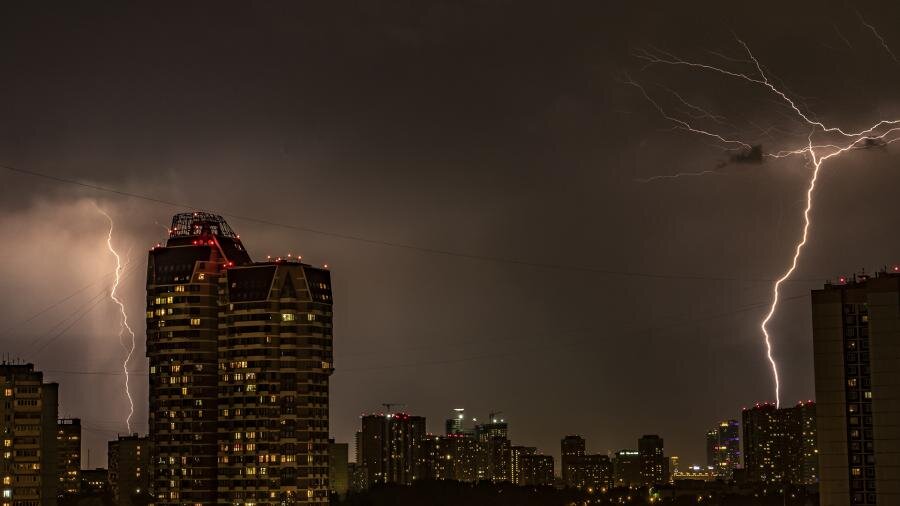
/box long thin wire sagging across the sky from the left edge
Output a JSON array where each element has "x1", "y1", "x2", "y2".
[{"x1": 0, "y1": 164, "x2": 821, "y2": 283}]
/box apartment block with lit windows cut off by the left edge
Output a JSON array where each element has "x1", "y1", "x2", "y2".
[{"x1": 0, "y1": 362, "x2": 59, "y2": 506}]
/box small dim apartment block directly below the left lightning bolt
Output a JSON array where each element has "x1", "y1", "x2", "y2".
[{"x1": 107, "y1": 434, "x2": 150, "y2": 506}]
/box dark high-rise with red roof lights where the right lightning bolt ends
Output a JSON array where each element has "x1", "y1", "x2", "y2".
[{"x1": 743, "y1": 402, "x2": 818, "y2": 485}]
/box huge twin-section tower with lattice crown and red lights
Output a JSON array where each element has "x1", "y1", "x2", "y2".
[{"x1": 147, "y1": 213, "x2": 332, "y2": 506}]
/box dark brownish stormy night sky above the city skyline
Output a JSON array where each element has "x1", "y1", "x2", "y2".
[{"x1": 0, "y1": 1, "x2": 900, "y2": 467}]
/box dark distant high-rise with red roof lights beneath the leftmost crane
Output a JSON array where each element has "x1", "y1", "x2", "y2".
[{"x1": 360, "y1": 413, "x2": 426, "y2": 486}]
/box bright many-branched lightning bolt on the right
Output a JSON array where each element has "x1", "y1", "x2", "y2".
[{"x1": 627, "y1": 37, "x2": 900, "y2": 407}]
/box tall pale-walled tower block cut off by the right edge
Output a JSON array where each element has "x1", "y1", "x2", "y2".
[{"x1": 812, "y1": 272, "x2": 900, "y2": 506}]
